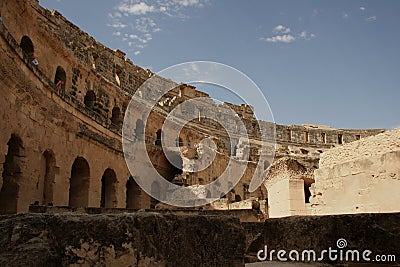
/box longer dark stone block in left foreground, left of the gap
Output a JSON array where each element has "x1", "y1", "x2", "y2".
[{"x1": 0, "y1": 212, "x2": 245, "y2": 267}]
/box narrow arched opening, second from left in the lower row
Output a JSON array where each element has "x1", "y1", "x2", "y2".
[{"x1": 42, "y1": 150, "x2": 56, "y2": 205}]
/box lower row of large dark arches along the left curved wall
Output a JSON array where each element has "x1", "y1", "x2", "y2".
[{"x1": 0, "y1": 134, "x2": 156, "y2": 214}]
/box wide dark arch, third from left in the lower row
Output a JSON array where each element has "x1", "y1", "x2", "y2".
[{"x1": 69, "y1": 157, "x2": 90, "y2": 207}]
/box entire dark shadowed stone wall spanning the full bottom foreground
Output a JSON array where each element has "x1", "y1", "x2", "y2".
[{"x1": 0, "y1": 212, "x2": 400, "y2": 267}]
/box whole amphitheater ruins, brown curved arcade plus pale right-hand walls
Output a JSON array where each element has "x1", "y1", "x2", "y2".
[{"x1": 0, "y1": 0, "x2": 400, "y2": 222}]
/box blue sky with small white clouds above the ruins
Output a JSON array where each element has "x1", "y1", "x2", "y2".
[{"x1": 40, "y1": 0, "x2": 400, "y2": 129}]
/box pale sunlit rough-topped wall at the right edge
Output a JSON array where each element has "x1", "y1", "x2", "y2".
[{"x1": 311, "y1": 129, "x2": 400, "y2": 214}]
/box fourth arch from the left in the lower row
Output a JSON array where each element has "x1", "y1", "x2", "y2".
[{"x1": 100, "y1": 169, "x2": 117, "y2": 208}]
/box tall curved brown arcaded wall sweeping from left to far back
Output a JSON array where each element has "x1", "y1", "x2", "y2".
[{"x1": 0, "y1": 0, "x2": 388, "y2": 215}]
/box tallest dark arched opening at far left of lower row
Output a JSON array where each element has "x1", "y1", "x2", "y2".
[{"x1": 0, "y1": 134, "x2": 24, "y2": 214}]
